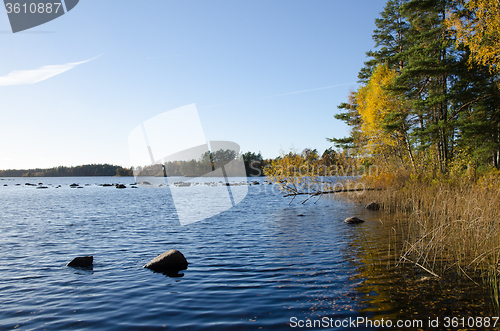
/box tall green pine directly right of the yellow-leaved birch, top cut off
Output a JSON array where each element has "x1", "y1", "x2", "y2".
[{"x1": 393, "y1": 0, "x2": 458, "y2": 172}]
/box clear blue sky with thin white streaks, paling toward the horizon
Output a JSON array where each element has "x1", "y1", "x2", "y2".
[{"x1": 0, "y1": 0, "x2": 386, "y2": 169}]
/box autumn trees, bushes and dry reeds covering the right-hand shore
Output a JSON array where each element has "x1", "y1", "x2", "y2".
[{"x1": 266, "y1": 0, "x2": 500, "y2": 311}]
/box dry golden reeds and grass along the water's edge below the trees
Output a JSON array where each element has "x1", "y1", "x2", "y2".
[{"x1": 349, "y1": 171, "x2": 500, "y2": 282}]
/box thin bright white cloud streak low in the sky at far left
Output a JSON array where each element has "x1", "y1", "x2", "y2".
[{"x1": 0, "y1": 55, "x2": 100, "y2": 86}]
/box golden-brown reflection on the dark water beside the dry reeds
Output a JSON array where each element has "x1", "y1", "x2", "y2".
[{"x1": 355, "y1": 212, "x2": 498, "y2": 329}]
